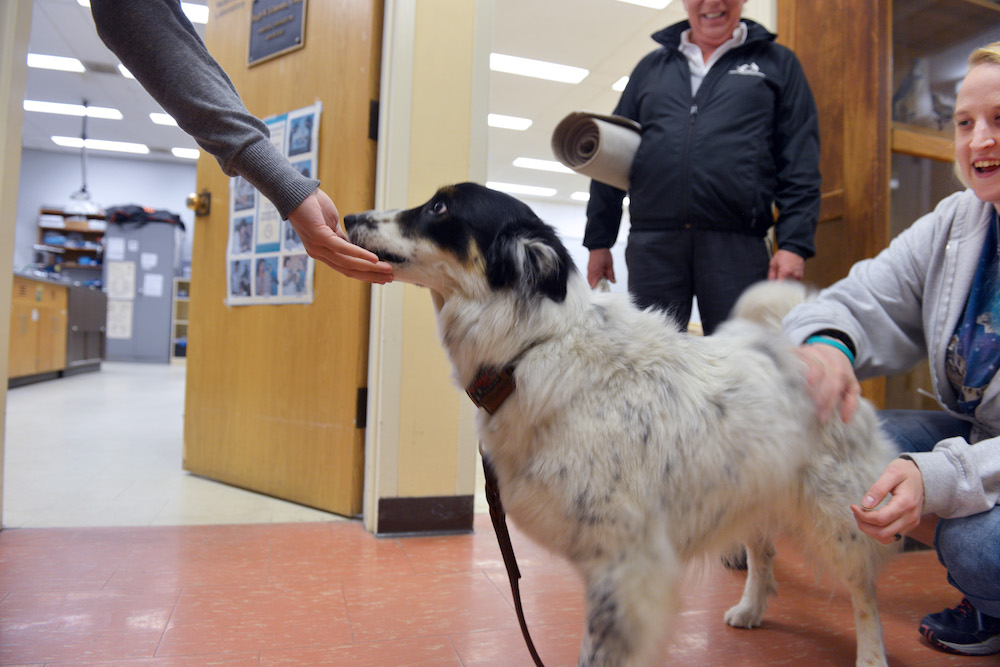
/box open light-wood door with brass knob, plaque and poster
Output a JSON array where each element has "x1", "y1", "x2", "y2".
[{"x1": 184, "y1": 0, "x2": 382, "y2": 516}]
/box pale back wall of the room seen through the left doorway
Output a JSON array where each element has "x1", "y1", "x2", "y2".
[{"x1": 14, "y1": 149, "x2": 196, "y2": 270}]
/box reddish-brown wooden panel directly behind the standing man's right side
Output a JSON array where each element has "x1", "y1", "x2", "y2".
[{"x1": 778, "y1": 0, "x2": 891, "y2": 406}]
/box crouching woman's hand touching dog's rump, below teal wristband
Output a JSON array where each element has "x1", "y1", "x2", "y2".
[{"x1": 795, "y1": 343, "x2": 861, "y2": 424}]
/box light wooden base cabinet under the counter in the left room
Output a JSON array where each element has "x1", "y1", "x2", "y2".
[{"x1": 7, "y1": 276, "x2": 67, "y2": 378}]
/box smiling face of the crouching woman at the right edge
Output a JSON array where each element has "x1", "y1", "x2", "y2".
[{"x1": 955, "y1": 63, "x2": 1000, "y2": 205}]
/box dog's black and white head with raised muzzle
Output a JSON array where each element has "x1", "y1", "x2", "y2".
[{"x1": 344, "y1": 183, "x2": 576, "y2": 302}]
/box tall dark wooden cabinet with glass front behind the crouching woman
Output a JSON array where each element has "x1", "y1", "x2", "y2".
[{"x1": 777, "y1": 0, "x2": 1000, "y2": 408}]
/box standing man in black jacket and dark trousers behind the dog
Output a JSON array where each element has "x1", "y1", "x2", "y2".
[{"x1": 583, "y1": 0, "x2": 820, "y2": 334}]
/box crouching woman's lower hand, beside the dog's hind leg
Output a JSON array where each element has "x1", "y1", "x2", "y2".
[{"x1": 851, "y1": 459, "x2": 924, "y2": 544}]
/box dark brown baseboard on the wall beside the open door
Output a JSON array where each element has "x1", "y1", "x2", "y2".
[{"x1": 375, "y1": 496, "x2": 475, "y2": 535}]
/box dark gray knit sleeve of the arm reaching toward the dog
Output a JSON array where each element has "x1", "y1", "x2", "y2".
[{"x1": 91, "y1": 0, "x2": 319, "y2": 218}]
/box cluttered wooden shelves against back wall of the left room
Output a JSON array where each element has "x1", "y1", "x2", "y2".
[{"x1": 35, "y1": 208, "x2": 107, "y2": 274}]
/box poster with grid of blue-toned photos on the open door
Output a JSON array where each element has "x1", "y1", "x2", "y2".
[{"x1": 226, "y1": 102, "x2": 322, "y2": 306}]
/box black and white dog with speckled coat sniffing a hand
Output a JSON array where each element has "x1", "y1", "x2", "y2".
[{"x1": 344, "y1": 183, "x2": 894, "y2": 666}]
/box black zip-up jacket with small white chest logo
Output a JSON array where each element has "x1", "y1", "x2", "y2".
[{"x1": 583, "y1": 19, "x2": 820, "y2": 258}]
